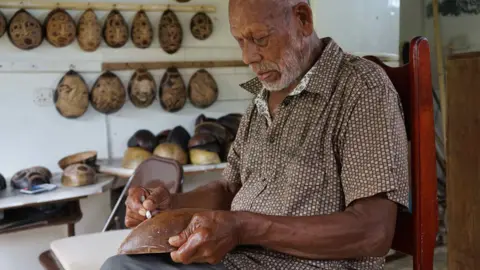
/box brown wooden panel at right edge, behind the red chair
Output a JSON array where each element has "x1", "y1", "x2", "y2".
[{"x1": 447, "y1": 53, "x2": 480, "y2": 270}]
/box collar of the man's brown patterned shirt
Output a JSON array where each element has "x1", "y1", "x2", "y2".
[{"x1": 240, "y1": 37, "x2": 344, "y2": 96}]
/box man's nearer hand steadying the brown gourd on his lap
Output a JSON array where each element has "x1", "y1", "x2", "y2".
[{"x1": 169, "y1": 211, "x2": 240, "y2": 264}]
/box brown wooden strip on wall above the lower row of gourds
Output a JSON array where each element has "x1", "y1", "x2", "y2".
[{"x1": 102, "y1": 60, "x2": 248, "y2": 71}]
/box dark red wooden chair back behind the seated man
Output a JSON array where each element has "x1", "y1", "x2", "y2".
[{"x1": 365, "y1": 37, "x2": 438, "y2": 270}]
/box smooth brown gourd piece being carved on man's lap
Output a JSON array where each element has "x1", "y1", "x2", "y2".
[{"x1": 118, "y1": 208, "x2": 205, "y2": 255}]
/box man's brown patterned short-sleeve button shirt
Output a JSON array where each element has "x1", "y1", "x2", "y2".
[{"x1": 223, "y1": 38, "x2": 409, "y2": 270}]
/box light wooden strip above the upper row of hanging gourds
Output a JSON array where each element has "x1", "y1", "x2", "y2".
[{"x1": 0, "y1": 0, "x2": 216, "y2": 13}]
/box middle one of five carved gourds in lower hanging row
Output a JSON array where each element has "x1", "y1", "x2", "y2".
[{"x1": 128, "y1": 69, "x2": 157, "y2": 108}]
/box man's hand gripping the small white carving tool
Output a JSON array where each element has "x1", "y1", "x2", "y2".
[{"x1": 125, "y1": 185, "x2": 171, "y2": 228}]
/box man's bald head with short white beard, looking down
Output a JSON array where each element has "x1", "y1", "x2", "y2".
[{"x1": 229, "y1": 0, "x2": 319, "y2": 91}]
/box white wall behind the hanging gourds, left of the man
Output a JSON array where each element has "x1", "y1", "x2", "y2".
[{"x1": 0, "y1": 0, "x2": 253, "y2": 270}]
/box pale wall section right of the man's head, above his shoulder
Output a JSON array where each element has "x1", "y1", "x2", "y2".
[{"x1": 310, "y1": 0, "x2": 403, "y2": 54}]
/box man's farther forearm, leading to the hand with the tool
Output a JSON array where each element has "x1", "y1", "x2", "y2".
[{"x1": 172, "y1": 180, "x2": 240, "y2": 210}]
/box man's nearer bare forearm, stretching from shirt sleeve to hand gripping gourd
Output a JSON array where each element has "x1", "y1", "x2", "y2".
[{"x1": 237, "y1": 196, "x2": 396, "y2": 259}]
